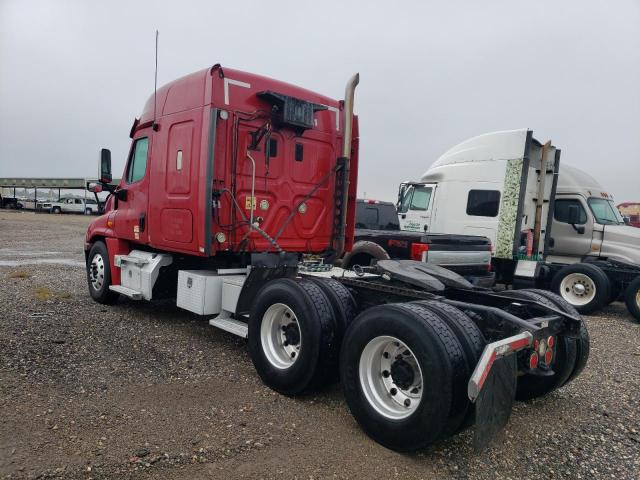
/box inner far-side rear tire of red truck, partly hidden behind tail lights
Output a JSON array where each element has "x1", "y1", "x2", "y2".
[{"x1": 500, "y1": 289, "x2": 577, "y2": 400}]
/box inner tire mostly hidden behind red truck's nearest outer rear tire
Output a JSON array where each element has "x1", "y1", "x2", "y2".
[{"x1": 415, "y1": 300, "x2": 487, "y2": 437}]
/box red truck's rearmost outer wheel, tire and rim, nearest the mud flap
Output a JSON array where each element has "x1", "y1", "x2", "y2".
[{"x1": 340, "y1": 303, "x2": 468, "y2": 452}]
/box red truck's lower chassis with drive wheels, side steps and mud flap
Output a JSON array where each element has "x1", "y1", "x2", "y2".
[{"x1": 87, "y1": 242, "x2": 589, "y2": 451}]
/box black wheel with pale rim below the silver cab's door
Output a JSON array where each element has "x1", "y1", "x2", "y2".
[{"x1": 551, "y1": 263, "x2": 611, "y2": 313}]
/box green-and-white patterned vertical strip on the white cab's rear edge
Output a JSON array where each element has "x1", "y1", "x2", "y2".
[{"x1": 495, "y1": 158, "x2": 523, "y2": 260}]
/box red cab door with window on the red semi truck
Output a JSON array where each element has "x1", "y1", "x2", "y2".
[{"x1": 114, "y1": 134, "x2": 151, "y2": 243}]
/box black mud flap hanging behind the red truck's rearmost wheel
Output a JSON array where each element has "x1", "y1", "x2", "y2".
[{"x1": 473, "y1": 355, "x2": 517, "y2": 452}]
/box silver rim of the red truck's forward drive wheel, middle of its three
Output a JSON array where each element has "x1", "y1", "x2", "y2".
[{"x1": 260, "y1": 303, "x2": 302, "y2": 370}]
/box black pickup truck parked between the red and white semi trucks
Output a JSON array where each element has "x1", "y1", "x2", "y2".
[{"x1": 340, "y1": 199, "x2": 494, "y2": 287}]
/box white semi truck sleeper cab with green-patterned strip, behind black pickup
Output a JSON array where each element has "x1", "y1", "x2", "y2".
[{"x1": 398, "y1": 129, "x2": 560, "y2": 260}]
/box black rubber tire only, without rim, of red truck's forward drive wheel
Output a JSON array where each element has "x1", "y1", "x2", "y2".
[{"x1": 248, "y1": 278, "x2": 339, "y2": 395}]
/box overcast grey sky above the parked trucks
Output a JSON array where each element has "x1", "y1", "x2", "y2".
[{"x1": 0, "y1": 0, "x2": 640, "y2": 201}]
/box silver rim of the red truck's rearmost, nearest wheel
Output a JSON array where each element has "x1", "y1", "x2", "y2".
[{"x1": 359, "y1": 336, "x2": 423, "y2": 420}]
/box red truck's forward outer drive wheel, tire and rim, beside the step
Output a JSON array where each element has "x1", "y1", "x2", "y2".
[{"x1": 249, "y1": 278, "x2": 338, "y2": 395}]
